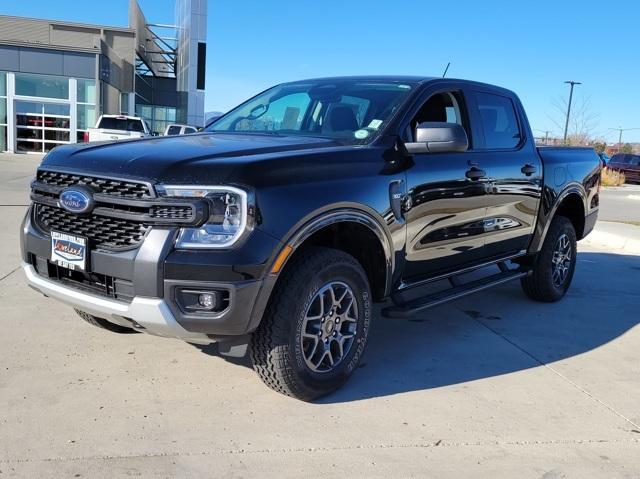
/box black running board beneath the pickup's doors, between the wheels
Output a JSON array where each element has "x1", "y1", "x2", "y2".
[{"x1": 382, "y1": 268, "x2": 530, "y2": 318}]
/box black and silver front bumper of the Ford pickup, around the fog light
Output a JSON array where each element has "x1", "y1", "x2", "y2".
[{"x1": 21, "y1": 208, "x2": 278, "y2": 344}]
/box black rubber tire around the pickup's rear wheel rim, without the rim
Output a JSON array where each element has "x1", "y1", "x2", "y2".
[{"x1": 520, "y1": 216, "x2": 577, "y2": 303}]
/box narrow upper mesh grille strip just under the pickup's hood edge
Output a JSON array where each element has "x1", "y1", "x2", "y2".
[{"x1": 37, "y1": 170, "x2": 153, "y2": 199}]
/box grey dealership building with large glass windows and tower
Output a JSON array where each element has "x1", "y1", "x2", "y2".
[{"x1": 0, "y1": 0, "x2": 207, "y2": 153}]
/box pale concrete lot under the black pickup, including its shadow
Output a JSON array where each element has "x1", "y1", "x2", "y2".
[{"x1": 0, "y1": 155, "x2": 640, "y2": 479}]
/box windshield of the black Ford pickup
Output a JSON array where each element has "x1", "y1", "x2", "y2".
[{"x1": 206, "y1": 80, "x2": 414, "y2": 144}]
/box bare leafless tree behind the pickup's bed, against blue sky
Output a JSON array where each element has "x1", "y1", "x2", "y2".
[{"x1": 549, "y1": 96, "x2": 600, "y2": 145}]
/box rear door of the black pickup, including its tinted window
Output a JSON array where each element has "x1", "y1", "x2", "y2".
[{"x1": 469, "y1": 90, "x2": 542, "y2": 257}]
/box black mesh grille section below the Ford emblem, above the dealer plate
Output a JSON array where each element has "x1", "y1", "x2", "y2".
[{"x1": 34, "y1": 204, "x2": 150, "y2": 249}]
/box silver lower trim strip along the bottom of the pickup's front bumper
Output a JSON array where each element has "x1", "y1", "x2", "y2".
[{"x1": 22, "y1": 261, "x2": 213, "y2": 344}]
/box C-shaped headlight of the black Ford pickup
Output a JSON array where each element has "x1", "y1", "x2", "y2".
[{"x1": 156, "y1": 185, "x2": 248, "y2": 249}]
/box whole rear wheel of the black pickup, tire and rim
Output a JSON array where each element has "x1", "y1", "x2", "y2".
[{"x1": 521, "y1": 216, "x2": 577, "y2": 303}]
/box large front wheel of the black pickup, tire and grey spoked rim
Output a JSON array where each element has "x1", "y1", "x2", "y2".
[{"x1": 251, "y1": 247, "x2": 371, "y2": 401}]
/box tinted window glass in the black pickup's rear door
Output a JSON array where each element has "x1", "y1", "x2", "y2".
[{"x1": 475, "y1": 92, "x2": 521, "y2": 150}]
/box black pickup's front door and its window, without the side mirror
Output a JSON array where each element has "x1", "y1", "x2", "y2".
[{"x1": 403, "y1": 91, "x2": 488, "y2": 284}]
